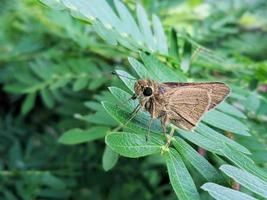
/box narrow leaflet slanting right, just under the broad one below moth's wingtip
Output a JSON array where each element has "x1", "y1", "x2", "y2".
[{"x1": 196, "y1": 123, "x2": 251, "y2": 154}]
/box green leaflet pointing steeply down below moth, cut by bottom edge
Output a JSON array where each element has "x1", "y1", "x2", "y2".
[{"x1": 164, "y1": 148, "x2": 200, "y2": 200}]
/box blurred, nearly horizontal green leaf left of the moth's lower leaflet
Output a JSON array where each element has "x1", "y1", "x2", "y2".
[{"x1": 58, "y1": 127, "x2": 108, "y2": 145}]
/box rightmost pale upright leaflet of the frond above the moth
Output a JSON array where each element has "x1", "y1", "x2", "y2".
[{"x1": 152, "y1": 15, "x2": 168, "y2": 55}]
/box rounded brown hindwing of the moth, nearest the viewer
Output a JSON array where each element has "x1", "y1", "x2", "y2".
[{"x1": 164, "y1": 87, "x2": 211, "y2": 130}]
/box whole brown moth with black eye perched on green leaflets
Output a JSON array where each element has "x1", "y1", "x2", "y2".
[{"x1": 130, "y1": 79, "x2": 230, "y2": 145}]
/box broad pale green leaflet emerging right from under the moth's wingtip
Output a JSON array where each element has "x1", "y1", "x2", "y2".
[{"x1": 203, "y1": 110, "x2": 250, "y2": 136}]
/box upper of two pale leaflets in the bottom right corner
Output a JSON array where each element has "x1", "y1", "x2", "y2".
[{"x1": 220, "y1": 165, "x2": 267, "y2": 198}]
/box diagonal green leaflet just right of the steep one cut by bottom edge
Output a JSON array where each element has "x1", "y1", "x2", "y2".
[{"x1": 172, "y1": 137, "x2": 221, "y2": 181}]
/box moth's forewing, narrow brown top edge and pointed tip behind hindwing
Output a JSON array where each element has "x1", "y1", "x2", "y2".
[{"x1": 162, "y1": 82, "x2": 230, "y2": 110}]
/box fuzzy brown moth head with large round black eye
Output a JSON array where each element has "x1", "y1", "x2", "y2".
[{"x1": 134, "y1": 80, "x2": 154, "y2": 97}]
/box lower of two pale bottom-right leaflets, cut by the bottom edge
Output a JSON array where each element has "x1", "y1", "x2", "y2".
[{"x1": 201, "y1": 183, "x2": 256, "y2": 200}]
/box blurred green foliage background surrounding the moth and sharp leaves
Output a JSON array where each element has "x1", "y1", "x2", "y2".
[{"x1": 0, "y1": 0, "x2": 267, "y2": 200}]
